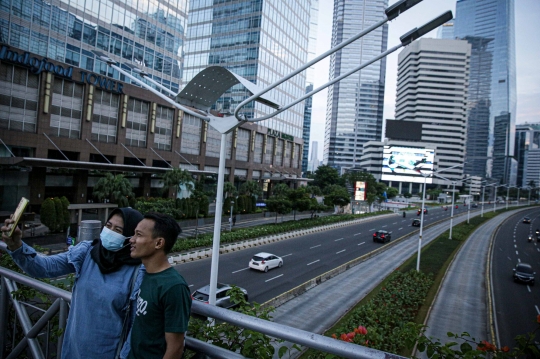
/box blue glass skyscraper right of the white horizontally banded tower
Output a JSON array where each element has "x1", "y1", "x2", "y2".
[{"x1": 454, "y1": 0, "x2": 516, "y2": 184}]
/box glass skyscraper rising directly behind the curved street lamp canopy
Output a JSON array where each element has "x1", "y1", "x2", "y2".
[{"x1": 184, "y1": 0, "x2": 310, "y2": 141}]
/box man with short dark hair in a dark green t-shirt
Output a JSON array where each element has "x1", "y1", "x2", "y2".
[{"x1": 128, "y1": 213, "x2": 191, "y2": 359}]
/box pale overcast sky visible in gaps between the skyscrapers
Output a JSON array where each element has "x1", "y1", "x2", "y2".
[{"x1": 310, "y1": 0, "x2": 540, "y2": 160}]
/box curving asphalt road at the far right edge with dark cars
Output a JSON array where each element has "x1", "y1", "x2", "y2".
[{"x1": 492, "y1": 209, "x2": 540, "y2": 348}]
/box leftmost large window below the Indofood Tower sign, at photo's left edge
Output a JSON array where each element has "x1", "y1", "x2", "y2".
[{"x1": 0, "y1": 63, "x2": 39, "y2": 133}]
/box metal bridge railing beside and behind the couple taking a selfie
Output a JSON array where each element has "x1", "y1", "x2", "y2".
[{"x1": 0, "y1": 267, "x2": 403, "y2": 359}]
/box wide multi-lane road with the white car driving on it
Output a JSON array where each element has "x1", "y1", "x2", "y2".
[{"x1": 176, "y1": 205, "x2": 472, "y2": 303}]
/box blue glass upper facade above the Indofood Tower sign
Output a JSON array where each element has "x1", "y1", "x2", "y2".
[{"x1": 0, "y1": 0, "x2": 188, "y2": 91}]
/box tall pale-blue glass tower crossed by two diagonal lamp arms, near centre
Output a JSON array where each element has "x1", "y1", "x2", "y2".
[{"x1": 323, "y1": 0, "x2": 388, "y2": 170}]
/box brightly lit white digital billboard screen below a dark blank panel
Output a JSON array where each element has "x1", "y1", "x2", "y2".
[{"x1": 381, "y1": 146, "x2": 435, "y2": 183}]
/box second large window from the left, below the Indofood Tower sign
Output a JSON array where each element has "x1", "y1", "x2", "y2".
[{"x1": 49, "y1": 77, "x2": 84, "y2": 139}]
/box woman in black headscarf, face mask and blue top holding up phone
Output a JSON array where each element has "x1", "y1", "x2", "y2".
[{"x1": 1, "y1": 208, "x2": 144, "y2": 359}]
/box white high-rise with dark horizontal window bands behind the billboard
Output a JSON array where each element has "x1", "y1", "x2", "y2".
[{"x1": 396, "y1": 39, "x2": 471, "y2": 183}]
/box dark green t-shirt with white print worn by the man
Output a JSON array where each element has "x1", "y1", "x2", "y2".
[{"x1": 128, "y1": 268, "x2": 191, "y2": 359}]
